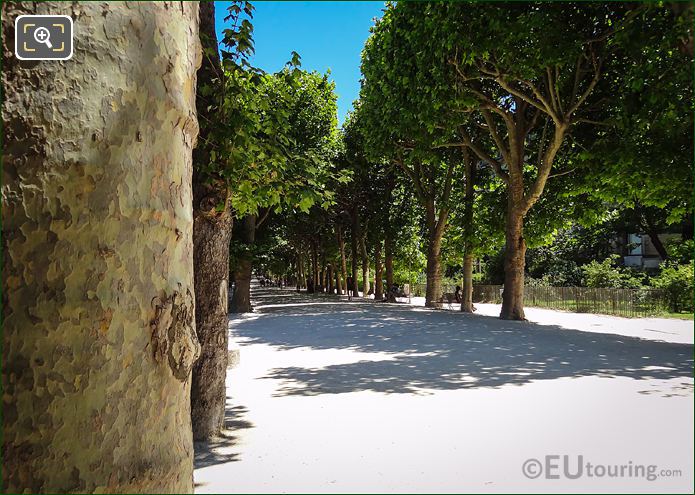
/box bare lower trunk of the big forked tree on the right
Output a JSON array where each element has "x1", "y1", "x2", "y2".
[{"x1": 500, "y1": 185, "x2": 526, "y2": 320}]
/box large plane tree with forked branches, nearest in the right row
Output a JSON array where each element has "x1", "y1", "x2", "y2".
[{"x1": 365, "y1": 3, "x2": 676, "y2": 319}]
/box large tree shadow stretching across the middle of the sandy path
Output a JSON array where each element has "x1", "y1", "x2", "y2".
[{"x1": 232, "y1": 289, "x2": 693, "y2": 396}]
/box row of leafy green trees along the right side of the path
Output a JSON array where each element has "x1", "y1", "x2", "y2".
[{"x1": 254, "y1": 3, "x2": 693, "y2": 319}]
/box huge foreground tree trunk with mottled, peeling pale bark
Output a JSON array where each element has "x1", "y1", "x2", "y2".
[{"x1": 2, "y1": 2, "x2": 200, "y2": 493}]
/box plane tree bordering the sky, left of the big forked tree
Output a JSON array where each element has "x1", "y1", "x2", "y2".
[{"x1": 359, "y1": 21, "x2": 463, "y2": 307}]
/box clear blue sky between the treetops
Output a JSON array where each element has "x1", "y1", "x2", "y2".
[{"x1": 215, "y1": 1, "x2": 384, "y2": 123}]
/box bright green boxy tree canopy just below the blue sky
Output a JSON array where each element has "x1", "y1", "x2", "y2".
[{"x1": 225, "y1": 67, "x2": 337, "y2": 216}]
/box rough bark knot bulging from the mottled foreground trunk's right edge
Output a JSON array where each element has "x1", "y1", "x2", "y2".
[{"x1": 150, "y1": 290, "x2": 200, "y2": 381}]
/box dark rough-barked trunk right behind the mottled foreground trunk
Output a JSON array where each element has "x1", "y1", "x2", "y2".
[{"x1": 191, "y1": 2, "x2": 232, "y2": 440}]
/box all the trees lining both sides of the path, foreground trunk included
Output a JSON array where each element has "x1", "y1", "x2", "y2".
[{"x1": 2, "y1": 1, "x2": 693, "y2": 492}]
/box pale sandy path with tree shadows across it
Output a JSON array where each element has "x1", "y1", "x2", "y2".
[{"x1": 195, "y1": 289, "x2": 695, "y2": 493}]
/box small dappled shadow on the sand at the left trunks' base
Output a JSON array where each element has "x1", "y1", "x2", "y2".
[{"x1": 193, "y1": 404, "x2": 254, "y2": 469}]
